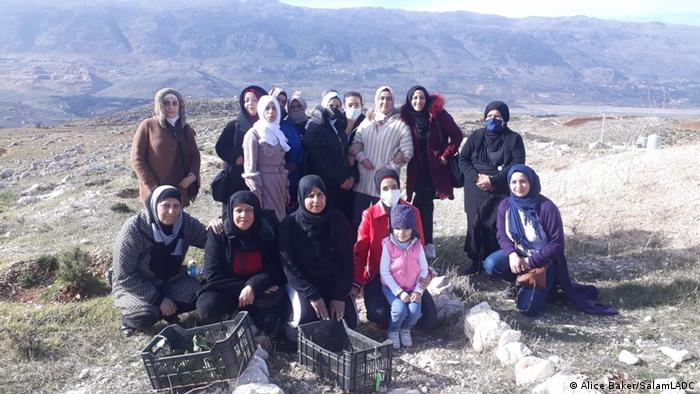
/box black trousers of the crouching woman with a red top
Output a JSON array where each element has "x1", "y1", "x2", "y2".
[{"x1": 197, "y1": 286, "x2": 287, "y2": 334}]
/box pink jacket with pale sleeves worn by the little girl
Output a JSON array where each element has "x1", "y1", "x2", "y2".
[{"x1": 379, "y1": 236, "x2": 428, "y2": 296}]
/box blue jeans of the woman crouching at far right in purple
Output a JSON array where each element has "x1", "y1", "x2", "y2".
[{"x1": 484, "y1": 250, "x2": 556, "y2": 316}]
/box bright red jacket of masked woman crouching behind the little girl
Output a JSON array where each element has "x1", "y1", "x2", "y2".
[{"x1": 352, "y1": 200, "x2": 425, "y2": 287}]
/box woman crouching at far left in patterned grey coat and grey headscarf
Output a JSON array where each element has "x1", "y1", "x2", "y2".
[{"x1": 112, "y1": 186, "x2": 207, "y2": 336}]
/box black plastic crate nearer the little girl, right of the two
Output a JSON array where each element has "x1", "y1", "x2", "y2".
[{"x1": 298, "y1": 320, "x2": 393, "y2": 393}]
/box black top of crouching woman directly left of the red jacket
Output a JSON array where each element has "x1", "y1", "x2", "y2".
[{"x1": 278, "y1": 210, "x2": 352, "y2": 301}]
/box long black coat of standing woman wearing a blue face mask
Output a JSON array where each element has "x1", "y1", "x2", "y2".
[{"x1": 459, "y1": 128, "x2": 525, "y2": 261}]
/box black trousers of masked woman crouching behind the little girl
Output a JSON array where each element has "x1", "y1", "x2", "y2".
[{"x1": 363, "y1": 276, "x2": 438, "y2": 330}]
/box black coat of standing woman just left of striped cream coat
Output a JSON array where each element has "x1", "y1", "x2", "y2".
[{"x1": 304, "y1": 107, "x2": 359, "y2": 190}]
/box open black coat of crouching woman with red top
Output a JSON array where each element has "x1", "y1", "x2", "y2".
[{"x1": 201, "y1": 217, "x2": 285, "y2": 298}]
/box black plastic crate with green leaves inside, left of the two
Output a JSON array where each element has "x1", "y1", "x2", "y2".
[{"x1": 141, "y1": 311, "x2": 255, "y2": 391}]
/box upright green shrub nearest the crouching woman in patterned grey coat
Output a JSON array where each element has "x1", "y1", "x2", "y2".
[{"x1": 56, "y1": 246, "x2": 107, "y2": 297}]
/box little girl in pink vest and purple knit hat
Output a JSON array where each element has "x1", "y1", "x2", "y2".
[{"x1": 379, "y1": 205, "x2": 428, "y2": 349}]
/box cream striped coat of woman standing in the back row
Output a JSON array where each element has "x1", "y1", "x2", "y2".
[{"x1": 352, "y1": 111, "x2": 413, "y2": 197}]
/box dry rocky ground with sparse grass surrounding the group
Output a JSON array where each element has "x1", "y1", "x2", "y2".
[{"x1": 0, "y1": 100, "x2": 700, "y2": 393}]
